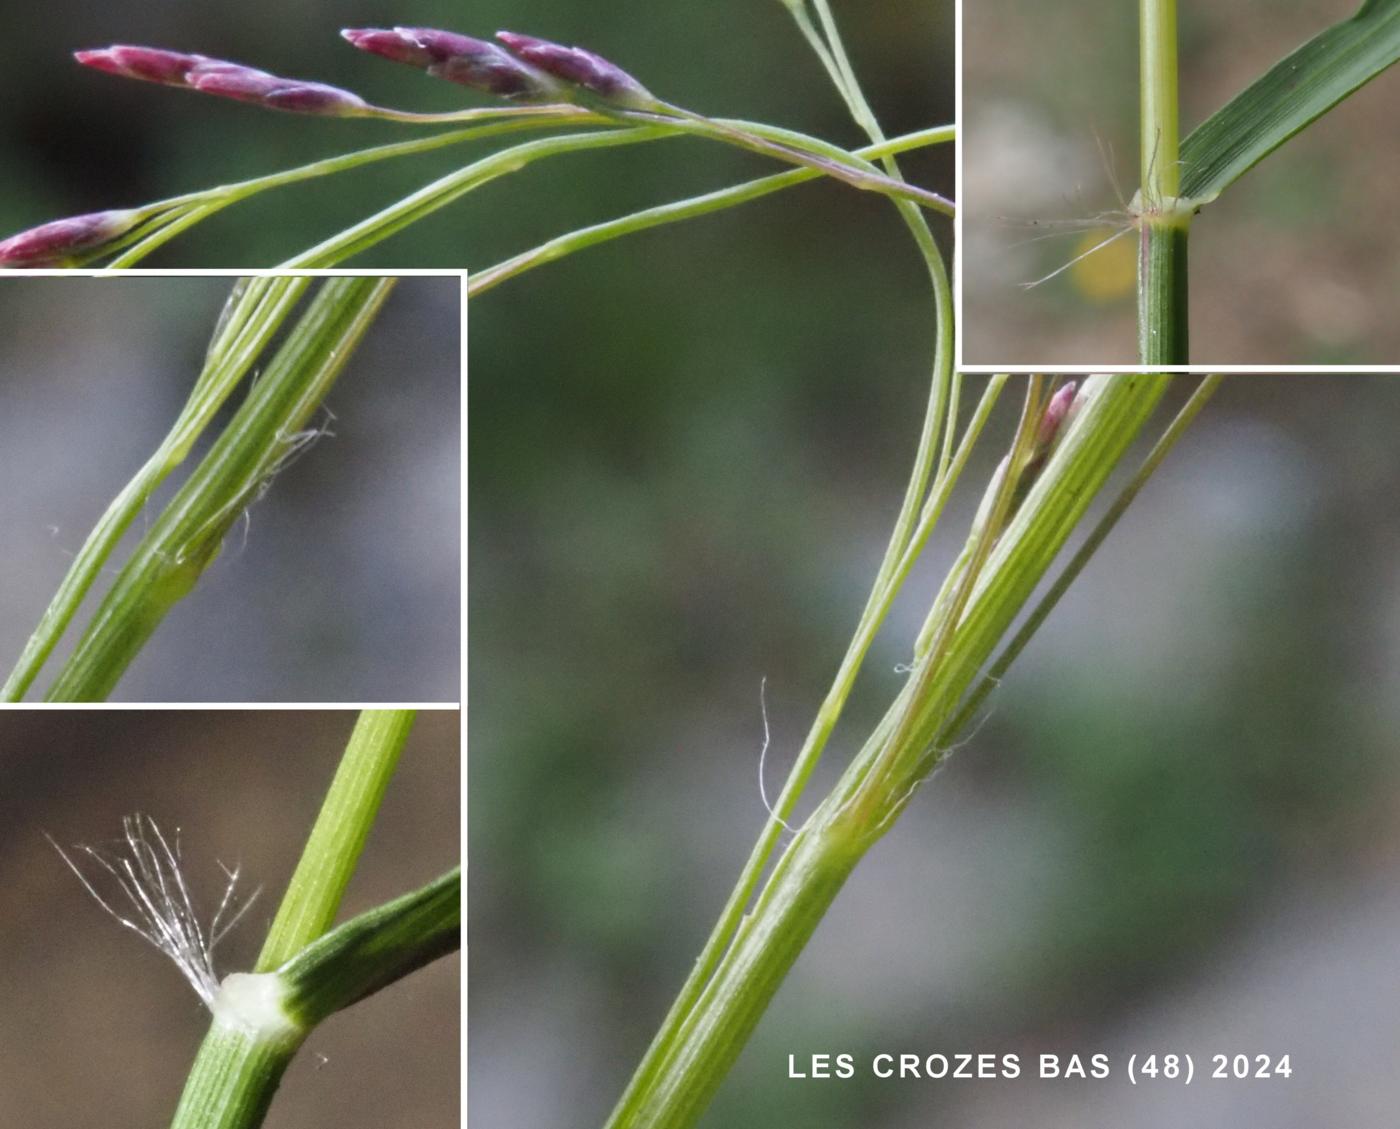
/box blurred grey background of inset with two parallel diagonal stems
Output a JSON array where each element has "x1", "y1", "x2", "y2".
[{"x1": 0, "y1": 277, "x2": 461, "y2": 702}]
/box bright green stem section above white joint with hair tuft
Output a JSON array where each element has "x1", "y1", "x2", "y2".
[{"x1": 253, "y1": 710, "x2": 416, "y2": 972}]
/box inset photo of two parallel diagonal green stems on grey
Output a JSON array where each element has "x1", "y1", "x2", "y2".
[{"x1": 0, "y1": 275, "x2": 462, "y2": 702}]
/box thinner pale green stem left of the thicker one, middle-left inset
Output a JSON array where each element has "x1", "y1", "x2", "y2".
[{"x1": 0, "y1": 279, "x2": 308, "y2": 702}]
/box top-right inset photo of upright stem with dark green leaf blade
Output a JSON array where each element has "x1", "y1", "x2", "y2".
[{"x1": 959, "y1": 0, "x2": 1400, "y2": 371}]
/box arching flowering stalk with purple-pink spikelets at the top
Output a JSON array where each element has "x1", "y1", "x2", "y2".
[{"x1": 0, "y1": 28, "x2": 953, "y2": 269}]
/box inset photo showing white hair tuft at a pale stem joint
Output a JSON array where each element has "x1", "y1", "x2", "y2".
[{"x1": 0, "y1": 707, "x2": 462, "y2": 1129}]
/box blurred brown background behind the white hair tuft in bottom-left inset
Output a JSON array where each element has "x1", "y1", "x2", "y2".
[{"x1": 0, "y1": 710, "x2": 461, "y2": 1129}]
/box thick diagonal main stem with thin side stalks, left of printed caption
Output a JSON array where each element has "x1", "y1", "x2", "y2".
[{"x1": 596, "y1": 15, "x2": 1208, "y2": 1129}]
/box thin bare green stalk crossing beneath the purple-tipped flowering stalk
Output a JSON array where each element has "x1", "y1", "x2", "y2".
[{"x1": 466, "y1": 126, "x2": 956, "y2": 297}]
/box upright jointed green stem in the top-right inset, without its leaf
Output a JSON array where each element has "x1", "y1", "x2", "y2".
[{"x1": 1135, "y1": 0, "x2": 1193, "y2": 367}]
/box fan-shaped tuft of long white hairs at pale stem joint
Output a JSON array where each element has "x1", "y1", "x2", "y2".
[{"x1": 45, "y1": 815, "x2": 258, "y2": 1007}]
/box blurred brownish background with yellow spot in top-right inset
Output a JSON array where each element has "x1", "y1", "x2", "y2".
[{"x1": 960, "y1": 0, "x2": 1400, "y2": 367}]
